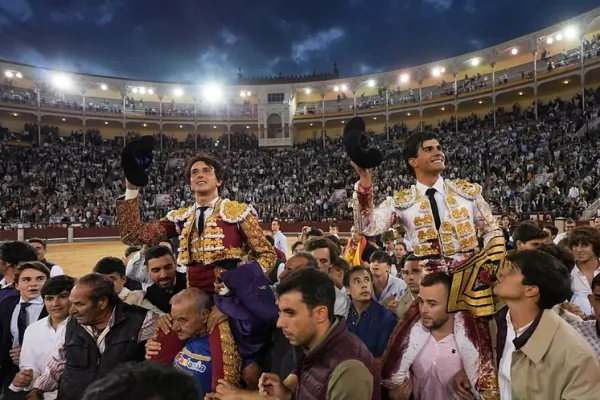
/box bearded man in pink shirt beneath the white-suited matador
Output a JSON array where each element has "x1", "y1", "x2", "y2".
[{"x1": 384, "y1": 272, "x2": 476, "y2": 400}]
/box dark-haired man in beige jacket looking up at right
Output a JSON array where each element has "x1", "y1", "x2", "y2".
[{"x1": 454, "y1": 250, "x2": 600, "y2": 400}]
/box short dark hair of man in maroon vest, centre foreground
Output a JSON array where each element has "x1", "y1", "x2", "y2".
[{"x1": 277, "y1": 268, "x2": 335, "y2": 322}]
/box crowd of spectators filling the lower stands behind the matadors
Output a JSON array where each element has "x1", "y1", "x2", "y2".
[{"x1": 0, "y1": 91, "x2": 600, "y2": 230}]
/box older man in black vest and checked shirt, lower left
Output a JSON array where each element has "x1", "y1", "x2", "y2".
[{"x1": 28, "y1": 274, "x2": 157, "y2": 400}]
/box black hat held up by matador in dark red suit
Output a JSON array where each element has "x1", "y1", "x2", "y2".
[{"x1": 121, "y1": 135, "x2": 155, "y2": 187}]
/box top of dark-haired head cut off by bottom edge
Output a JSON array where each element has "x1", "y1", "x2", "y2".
[{"x1": 82, "y1": 361, "x2": 199, "y2": 400}]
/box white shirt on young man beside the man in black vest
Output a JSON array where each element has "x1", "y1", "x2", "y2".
[{"x1": 10, "y1": 317, "x2": 69, "y2": 400}]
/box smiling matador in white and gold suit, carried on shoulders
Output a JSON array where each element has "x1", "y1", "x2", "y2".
[{"x1": 352, "y1": 132, "x2": 505, "y2": 399}]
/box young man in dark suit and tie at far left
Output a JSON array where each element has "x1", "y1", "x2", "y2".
[{"x1": 0, "y1": 261, "x2": 50, "y2": 396}]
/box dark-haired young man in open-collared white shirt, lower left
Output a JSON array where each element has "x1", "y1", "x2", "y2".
[{"x1": 9, "y1": 275, "x2": 75, "y2": 400}]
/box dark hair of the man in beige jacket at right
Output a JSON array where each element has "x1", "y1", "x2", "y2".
[{"x1": 506, "y1": 250, "x2": 571, "y2": 310}]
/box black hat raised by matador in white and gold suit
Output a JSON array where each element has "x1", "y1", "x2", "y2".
[{"x1": 344, "y1": 117, "x2": 384, "y2": 169}]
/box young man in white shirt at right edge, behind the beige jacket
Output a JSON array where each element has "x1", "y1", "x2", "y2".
[{"x1": 569, "y1": 226, "x2": 600, "y2": 316}]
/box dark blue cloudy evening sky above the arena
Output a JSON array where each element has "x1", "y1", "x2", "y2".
[{"x1": 0, "y1": 0, "x2": 600, "y2": 82}]
